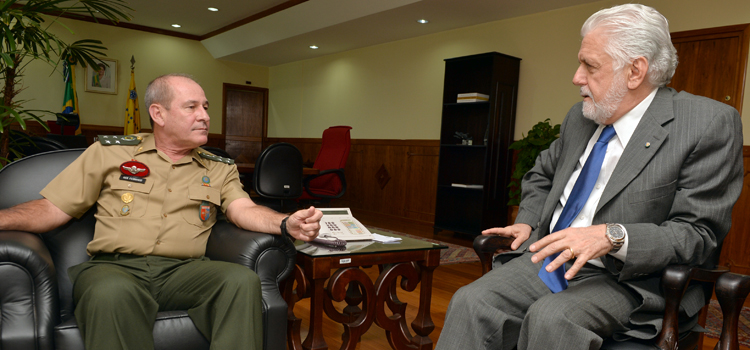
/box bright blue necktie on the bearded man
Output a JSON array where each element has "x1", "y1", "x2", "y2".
[{"x1": 539, "y1": 125, "x2": 615, "y2": 293}]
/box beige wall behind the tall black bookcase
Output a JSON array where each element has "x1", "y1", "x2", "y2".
[{"x1": 268, "y1": 0, "x2": 750, "y2": 143}]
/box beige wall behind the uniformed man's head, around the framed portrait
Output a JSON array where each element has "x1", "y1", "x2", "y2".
[{"x1": 19, "y1": 20, "x2": 268, "y2": 133}]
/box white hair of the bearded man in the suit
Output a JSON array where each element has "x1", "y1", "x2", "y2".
[{"x1": 581, "y1": 4, "x2": 677, "y2": 87}]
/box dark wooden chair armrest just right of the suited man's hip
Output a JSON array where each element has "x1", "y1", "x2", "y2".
[{"x1": 656, "y1": 265, "x2": 728, "y2": 349}]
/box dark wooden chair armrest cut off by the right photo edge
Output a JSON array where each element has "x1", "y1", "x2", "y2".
[{"x1": 716, "y1": 273, "x2": 750, "y2": 350}]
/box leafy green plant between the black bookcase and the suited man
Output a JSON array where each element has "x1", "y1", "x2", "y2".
[{"x1": 508, "y1": 119, "x2": 560, "y2": 215}]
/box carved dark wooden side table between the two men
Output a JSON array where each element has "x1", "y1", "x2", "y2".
[{"x1": 284, "y1": 231, "x2": 447, "y2": 350}]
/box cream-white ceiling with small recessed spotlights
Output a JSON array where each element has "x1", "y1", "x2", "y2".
[{"x1": 126, "y1": 0, "x2": 598, "y2": 66}]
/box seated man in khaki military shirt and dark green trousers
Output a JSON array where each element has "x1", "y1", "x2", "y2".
[{"x1": 0, "y1": 74, "x2": 322, "y2": 350}]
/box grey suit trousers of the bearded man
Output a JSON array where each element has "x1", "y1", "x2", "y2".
[{"x1": 435, "y1": 253, "x2": 640, "y2": 350}]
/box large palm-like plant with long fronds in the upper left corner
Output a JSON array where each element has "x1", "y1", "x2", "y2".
[{"x1": 0, "y1": 0, "x2": 132, "y2": 167}]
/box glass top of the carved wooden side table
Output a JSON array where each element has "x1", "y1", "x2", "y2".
[{"x1": 294, "y1": 229, "x2": 448, "y2": 257}]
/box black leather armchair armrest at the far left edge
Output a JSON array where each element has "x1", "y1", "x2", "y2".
[{"x1": 0, "y1": 231, "x2": 60, "y2": 350}]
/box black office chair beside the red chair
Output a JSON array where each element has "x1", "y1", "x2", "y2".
[{"x1": 253, "y1": 142, "x2": 302, "y2": 213}]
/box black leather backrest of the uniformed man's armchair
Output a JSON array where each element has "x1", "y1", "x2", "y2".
[{"x1": 0, "y1": 148, "x2": 96, "y2": 321}]
